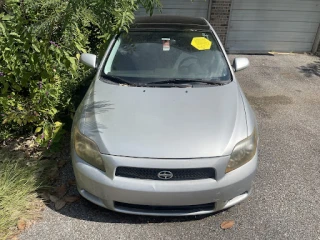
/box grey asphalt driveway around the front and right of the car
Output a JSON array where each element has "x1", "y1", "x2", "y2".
[{"x1": 20, "y1": 55, "x2": 320, "y2": 240}]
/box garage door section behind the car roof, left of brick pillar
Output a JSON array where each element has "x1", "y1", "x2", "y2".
[{"x1": 136, "y1": 0, "x2": 210, "y2": 18}]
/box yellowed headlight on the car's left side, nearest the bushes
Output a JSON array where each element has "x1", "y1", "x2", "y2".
[{"x1": 74, "y1": 127, "x2": 105, "y2": 171}]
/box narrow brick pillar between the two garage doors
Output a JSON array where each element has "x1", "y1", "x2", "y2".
[{"x1": 210, "y1": 0, "x2": 232, "y2": 45}]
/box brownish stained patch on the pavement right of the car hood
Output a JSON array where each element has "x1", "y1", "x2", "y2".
[{"x1": 247, "y1": 95, "x2": 293, "y2": 118}]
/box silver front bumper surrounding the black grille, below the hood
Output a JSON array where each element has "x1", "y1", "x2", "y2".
[{"x1": 72, "y1": 150, "x2": 258, "y2": 216}]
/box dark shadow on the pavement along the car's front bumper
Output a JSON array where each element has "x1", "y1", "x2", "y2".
[{"x1": 46, "y1": 160, "x2": 219, "y2": 224}]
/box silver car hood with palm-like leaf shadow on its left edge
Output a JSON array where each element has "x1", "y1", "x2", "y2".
[{"x1": 80, "y1": 80, "x2": 248, "y2": 159}]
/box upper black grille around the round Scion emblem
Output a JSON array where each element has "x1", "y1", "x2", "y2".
[{"x1": 116, "y1": 167, "x2": 215, "y2": 181}]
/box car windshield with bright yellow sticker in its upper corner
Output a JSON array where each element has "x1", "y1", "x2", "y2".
[{"x1": 102, "y1": 31, "x2": 231, "y2": 84}]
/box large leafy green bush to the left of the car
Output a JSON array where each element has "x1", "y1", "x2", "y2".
[{"x1": 0, "y1": 0, "x2": 159, "y2": 144}]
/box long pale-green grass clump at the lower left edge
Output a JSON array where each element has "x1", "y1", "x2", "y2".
[{"x1": 0, "y1": 149, "x2": 40, "y2": 239}]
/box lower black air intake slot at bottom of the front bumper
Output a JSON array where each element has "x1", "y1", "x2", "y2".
[{"x1": 114, "y1": 202, "x2": 215, "y2": 214}]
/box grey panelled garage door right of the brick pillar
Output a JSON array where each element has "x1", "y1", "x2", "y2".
[{"x1": 226, "y1": 0, "x2": 320, "y2": 53}]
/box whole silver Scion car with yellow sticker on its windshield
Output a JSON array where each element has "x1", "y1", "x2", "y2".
[{"x1": 71, "y1": 16, "x2": 258, "y2": 216}]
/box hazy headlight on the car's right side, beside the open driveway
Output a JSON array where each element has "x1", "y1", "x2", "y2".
[{"x1": 226, "y1": 128, "x2": 258, "y2": 173}]
